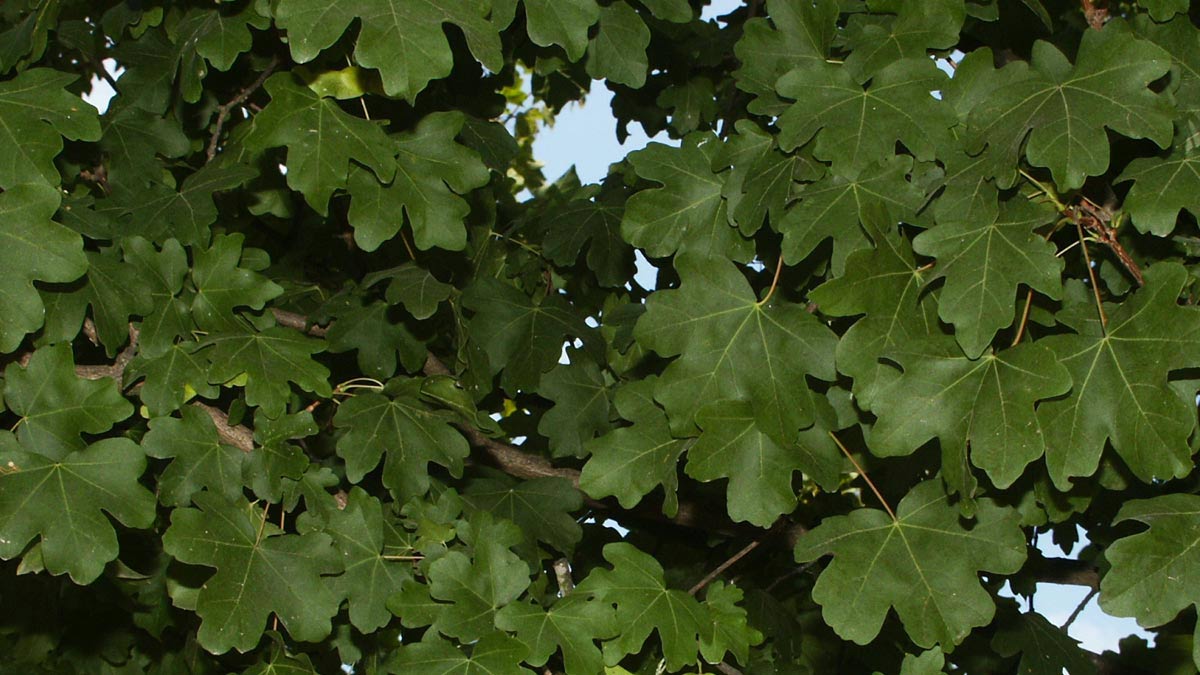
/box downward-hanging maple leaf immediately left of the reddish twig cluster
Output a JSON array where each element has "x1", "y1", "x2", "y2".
[{"x1": 912, "y1": 196, "x2": 1063, "y2": 358}]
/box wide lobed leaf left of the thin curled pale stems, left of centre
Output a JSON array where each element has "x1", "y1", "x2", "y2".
[{"x1": 205, "y1": 327, "x2": 332, "y2": 417}]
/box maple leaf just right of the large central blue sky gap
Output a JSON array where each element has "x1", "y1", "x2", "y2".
[{"x1": 620, "y1": 132, "x2": 754, "y2": 261}]
